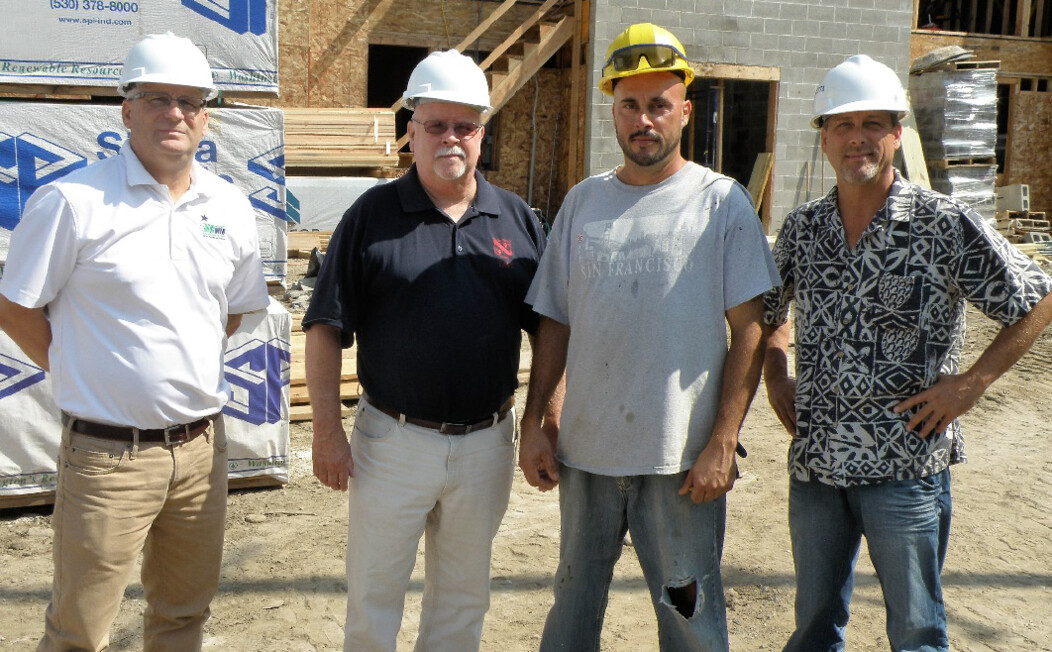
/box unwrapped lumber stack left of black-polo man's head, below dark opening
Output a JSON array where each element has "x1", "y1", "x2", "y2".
[{"x1": 283, "y1": 108, "x2": 398, "y2": 167}]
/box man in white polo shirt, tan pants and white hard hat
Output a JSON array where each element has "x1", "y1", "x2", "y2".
[{"x1": 0, "y1": 34, "x2": 267, "y2": 652}]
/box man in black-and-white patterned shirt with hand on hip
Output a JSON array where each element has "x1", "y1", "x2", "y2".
[{"x1": 765, "y1": 55, "x2": 1052, "y2": 652}]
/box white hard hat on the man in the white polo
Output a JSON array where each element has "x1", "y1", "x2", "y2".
[{"x1": 117, "y1": 32, "x2": 218, "y2": 100}]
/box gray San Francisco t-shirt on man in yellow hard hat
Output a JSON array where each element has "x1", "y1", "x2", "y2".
[{"x1": 527, "y1": 163, "x2": 778, "y2": 475}]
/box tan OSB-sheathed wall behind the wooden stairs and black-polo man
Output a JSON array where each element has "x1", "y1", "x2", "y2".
[{"x1": 260, "y1": 0, "x2": 580, "y2": 209}]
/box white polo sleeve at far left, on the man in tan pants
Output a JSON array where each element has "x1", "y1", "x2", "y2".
[{"x1": 0, "y1": 185, "x2": 78, "y2": 308}]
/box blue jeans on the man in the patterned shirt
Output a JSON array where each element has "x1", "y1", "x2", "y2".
[{"x1": 785, "y1": 470, "x2": 951, "y2": 652}]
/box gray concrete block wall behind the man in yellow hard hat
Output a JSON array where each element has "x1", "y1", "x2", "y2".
[{"x1": 585, "y1": 0, "x2": 913, "y2": 233}]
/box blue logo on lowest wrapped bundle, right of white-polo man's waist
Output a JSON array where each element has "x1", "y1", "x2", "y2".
[{"x1": 223, "y1": 338, "x2": 292, "y2": 426}]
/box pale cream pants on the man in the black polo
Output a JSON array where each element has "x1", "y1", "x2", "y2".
[{"x1": 343, "y1": 399, "x2": 517, "y2": 652}]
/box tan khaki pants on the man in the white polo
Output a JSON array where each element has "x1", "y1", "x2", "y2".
[{"x1": 37, "y1": 419, "x2": 226, "y2": 652}]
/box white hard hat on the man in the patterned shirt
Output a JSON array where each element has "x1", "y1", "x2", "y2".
[{"x1": 811, "y1": 55, "x2": 910, "y2": 129}]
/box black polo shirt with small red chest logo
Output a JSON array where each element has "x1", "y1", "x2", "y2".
[{"x1": 303, "y1": 165, "x2": 545, "y2": 423}]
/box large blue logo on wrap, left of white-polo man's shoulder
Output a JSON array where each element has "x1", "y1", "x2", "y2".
[{"x1": 0, "y1": 131, "x2": 87, "y2": 230}]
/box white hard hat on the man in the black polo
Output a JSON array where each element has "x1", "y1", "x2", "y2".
[{"x1": 402, "y1": 49, "x2": 492, "y2": 113}]
